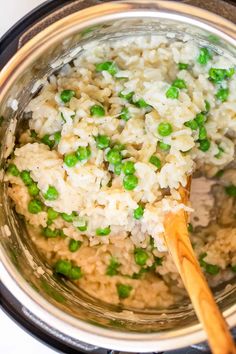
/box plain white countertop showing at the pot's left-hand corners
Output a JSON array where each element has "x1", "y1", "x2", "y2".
[{"x1": 0, "y1": 0, "x2": 56, "y2": 354}]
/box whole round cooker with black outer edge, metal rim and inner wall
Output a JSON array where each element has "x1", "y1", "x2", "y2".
[{"x1": 0, "y1": 0, "x2": 236, "y2": 353}]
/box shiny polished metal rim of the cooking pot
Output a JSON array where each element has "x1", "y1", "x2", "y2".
[{"x1": 0, "y1": 0, "x2": 236, "y2": 352}]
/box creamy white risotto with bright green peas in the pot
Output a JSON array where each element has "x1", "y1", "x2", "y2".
[{"x1": 5, "y1": 36, "x2": 236, "y2": 308}]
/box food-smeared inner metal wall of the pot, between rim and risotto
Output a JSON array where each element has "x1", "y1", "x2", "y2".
[{"x1": 0, "y1": 18, "x2": 236, "y2": 332}]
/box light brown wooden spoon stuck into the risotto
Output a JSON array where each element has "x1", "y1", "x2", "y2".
[{"x1": 164, "y1": 178, "x2": 236, "y2": 354}]
